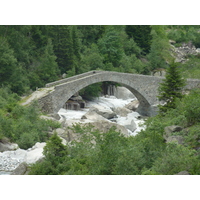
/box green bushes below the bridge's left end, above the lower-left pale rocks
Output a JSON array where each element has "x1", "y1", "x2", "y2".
[{"x1": 0, "y1": 88, "x2": 60, "y2": 149}]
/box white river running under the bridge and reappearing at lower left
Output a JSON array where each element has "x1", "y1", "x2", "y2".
[{"x1": 0, "y1": 88, "x2": 145, "y2": 175}]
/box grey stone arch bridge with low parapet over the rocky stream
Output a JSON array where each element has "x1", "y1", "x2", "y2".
[{"x1": 24, "y1": 71, "x2": 200, "y2": 116}]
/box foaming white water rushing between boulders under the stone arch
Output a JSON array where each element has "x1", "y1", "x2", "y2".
[{"x1": 58, "y1": 96, "x2": 144, "y2": 135}]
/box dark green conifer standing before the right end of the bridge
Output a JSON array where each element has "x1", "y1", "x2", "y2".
[{"x1": 158, "y1": 62, "x2": 185, "y2": 113}]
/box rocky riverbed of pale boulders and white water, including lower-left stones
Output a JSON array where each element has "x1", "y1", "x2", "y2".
[{"x1": 0, "y1": 87, "x2": 143, "y2": 175}]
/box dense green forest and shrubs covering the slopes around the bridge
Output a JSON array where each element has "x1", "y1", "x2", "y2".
[{"x1": 0, "y1": 25, "x2": 200, "y2": 175}]
